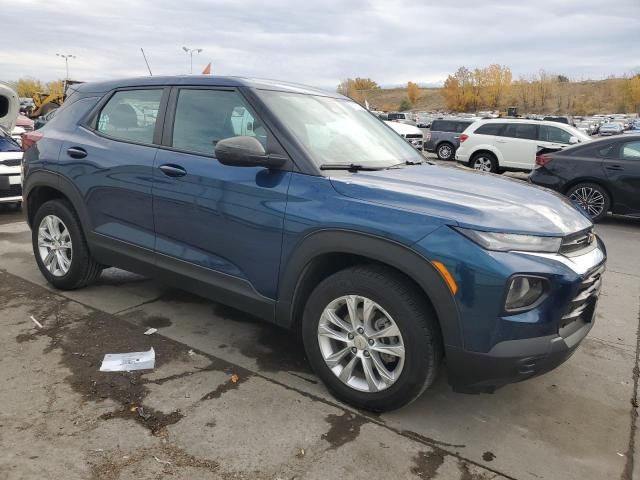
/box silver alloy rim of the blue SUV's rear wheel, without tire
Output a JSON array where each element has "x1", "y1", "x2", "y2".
[{"x1": 38, "y1": 215, "x2": 73, "y2": 277}]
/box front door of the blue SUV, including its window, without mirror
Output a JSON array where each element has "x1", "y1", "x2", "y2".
[{"x1": 153, "y1": 87, "x2": 291, "y2": 303}]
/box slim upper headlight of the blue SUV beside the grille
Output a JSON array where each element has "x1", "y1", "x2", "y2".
[{"x1": 455, "y1": 227, "x2": 562, "y2": 253}]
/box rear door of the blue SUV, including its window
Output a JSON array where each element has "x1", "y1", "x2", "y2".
[{"x1": 58, "y1": 87, "x2": 168, "y2": 249}]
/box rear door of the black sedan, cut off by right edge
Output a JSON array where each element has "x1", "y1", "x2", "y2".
[{"x1": 604, "y1": 139, "x2": 640, "y2": 213}]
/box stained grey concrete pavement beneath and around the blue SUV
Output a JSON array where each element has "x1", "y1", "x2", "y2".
[{"x1": 0, "y1": 208, "x2": 640, "y2": 480}]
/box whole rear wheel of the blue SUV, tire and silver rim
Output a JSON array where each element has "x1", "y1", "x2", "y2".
[{"x1": 31, "y1": 200, "x2": 102, "y2": 290}]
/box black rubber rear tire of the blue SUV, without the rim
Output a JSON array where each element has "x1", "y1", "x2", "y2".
[{"x1": 31, "y1": 200, "x2": 103, "y2": 290}]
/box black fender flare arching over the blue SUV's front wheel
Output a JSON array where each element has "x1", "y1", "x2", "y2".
[{"x1": 276, "y1": 229, "x2": 462, "y2": 347}]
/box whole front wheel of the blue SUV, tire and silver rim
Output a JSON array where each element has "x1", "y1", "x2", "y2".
[{"x1": 302, "y1": 266, "x2": 442, "y2": 411}]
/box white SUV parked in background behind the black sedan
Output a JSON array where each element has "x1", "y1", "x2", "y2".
[{"x1": 456, "y1": 119, "x2": 591, "y2": 173}]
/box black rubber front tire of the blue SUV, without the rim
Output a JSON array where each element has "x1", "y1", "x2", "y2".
[{"x1": 302, "y1": 265, "x2": 442, "y2": 412}]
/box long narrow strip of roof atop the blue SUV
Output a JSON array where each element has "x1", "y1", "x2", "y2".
[{"x1": 71, "y1": 75, "x2": 346, "y2": 99}]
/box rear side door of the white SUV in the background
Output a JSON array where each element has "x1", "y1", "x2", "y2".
[{"x1": 494, "y1": 123, "x2": 538, "y2": 170}]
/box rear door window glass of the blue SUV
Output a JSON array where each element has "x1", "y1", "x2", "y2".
[{"x1": 96, "y1": 89, "x2": 162, "y2": 143}]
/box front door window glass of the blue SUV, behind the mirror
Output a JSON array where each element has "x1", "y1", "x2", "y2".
[{"x1": 172, "y1": 89, "x2": 267, "y2": 154}]
